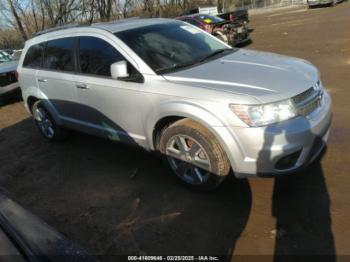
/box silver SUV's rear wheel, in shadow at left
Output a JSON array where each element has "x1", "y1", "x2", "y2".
[{"x1": 32, "y1": 101, "x2": 68, "y2": 142}]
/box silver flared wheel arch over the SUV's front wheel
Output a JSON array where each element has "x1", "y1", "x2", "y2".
[{"x1": 145, "y1": 101, "x2": 242, "y2": 170}]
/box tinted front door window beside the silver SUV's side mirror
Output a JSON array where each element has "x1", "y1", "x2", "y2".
[{"x1": 78, "y1": 36, "x2": 125, "y2": 76}]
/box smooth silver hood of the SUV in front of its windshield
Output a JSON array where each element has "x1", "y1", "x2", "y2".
[{"x1": 163, "y1": 49, "x2": 319, "y2": 103}]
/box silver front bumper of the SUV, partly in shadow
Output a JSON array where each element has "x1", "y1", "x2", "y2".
[{"x1": 228, "y1": 92, "x2": 332, "y2": 177}]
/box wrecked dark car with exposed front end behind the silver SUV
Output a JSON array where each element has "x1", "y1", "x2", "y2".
[{"x1": 176, "y1": 14, "x2": 249, "y2": 46}]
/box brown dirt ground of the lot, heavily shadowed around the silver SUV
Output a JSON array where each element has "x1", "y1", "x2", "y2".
[{"x1": 0, "y1": 2, "x2": 350, "y2": 261}]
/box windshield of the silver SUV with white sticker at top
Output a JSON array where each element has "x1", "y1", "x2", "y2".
[{"x1": 115, "y1": 21, "x2": 233, "y2": 74}]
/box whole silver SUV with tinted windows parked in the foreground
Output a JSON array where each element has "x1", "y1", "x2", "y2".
[{"x1": 18, "y1": 19, "x2": 331, "y2": 190}]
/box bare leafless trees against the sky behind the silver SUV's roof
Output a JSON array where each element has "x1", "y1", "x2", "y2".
[{"x1": 0, "y1": 0, "x2": 232, "y2": 48}]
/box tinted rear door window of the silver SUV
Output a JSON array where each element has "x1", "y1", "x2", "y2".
[{"x1": 43, "y1": 37, "x2": 75, "y2": 71}]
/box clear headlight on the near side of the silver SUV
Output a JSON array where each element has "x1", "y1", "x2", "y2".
[{"x1": 230, "y1": 99, "x2": 297, "y2": 127}]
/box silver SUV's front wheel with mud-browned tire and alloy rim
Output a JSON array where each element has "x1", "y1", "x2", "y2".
[{"x1": 159, "y1": 119, "x2": 230, "y2": 191}]
